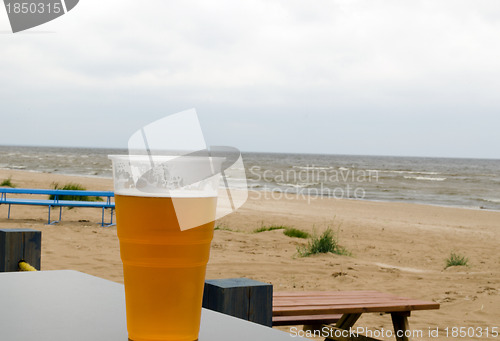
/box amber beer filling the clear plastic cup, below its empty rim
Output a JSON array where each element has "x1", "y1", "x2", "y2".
[{"x1": 115, "y1": 193, "x2": 217, "y2": 341}]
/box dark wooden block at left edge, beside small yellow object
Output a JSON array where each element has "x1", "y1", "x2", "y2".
[{"x1": 0, "y1": 229, "x2": 42, "y2": 272}]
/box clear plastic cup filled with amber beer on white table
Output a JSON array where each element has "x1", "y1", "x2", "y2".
[{"x1": 109, "y1": 155, "x2": 223, "y2": 341}]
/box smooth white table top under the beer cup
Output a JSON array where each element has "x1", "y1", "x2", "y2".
[{"x1": 0, "y1": 270, "x2": 306, "y2": 341}]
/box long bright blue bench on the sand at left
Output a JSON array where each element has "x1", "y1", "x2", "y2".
[{"x1": 0, "y1": 188, "x2": 115, "y2": 226}]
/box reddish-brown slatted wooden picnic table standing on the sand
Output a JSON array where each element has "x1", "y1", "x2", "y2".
[{"x1": 273, "y1": 291, "x2": 439, "y2": 341}]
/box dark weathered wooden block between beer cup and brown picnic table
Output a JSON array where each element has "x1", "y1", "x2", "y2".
[{"x1": 203, "y1": 278, "x2": 273, "y2": 327}]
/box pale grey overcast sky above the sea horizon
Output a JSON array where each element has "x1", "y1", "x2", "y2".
[{"x1": 0, "y1": 0, "x2": 500, "y2": 158}]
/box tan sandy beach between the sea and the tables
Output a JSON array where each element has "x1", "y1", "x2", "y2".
[{"x1": 0, "y1": 170, "x2": 500, "y2": 340}]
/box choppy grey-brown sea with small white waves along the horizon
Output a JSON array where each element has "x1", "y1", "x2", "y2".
[{"x1": 0, "y1": 146, "x2": 500, "y2": 210}]
